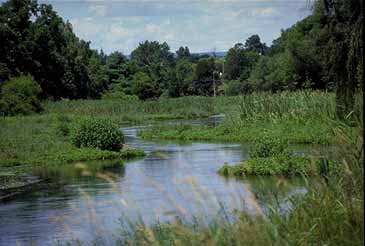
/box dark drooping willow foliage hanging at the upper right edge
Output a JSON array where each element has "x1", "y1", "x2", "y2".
[{"x1": 314, "y1": 0, "x2": 363, "y2": 119}]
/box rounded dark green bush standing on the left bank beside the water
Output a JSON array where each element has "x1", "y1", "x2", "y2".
[{"x1": 71, "y1": 119, "x2": 124, "y2": 151}]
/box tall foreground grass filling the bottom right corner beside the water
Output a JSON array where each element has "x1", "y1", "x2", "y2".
[{"x1": 109, "y1": 93, "x2": 364, "y2": 245}]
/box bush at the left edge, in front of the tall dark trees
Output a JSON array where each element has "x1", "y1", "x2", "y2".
[{"x1": 0, "y1": 75, "x2": 42, "y2": 115}]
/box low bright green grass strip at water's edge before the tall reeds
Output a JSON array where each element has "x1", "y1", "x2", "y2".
[{"x1": 140, "y1": 119, "x2": 333, "y2": 144}]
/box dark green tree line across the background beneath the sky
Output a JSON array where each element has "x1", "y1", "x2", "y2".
[{"x1": 0, "y1": 0, "x2": 363, "y2": 118}]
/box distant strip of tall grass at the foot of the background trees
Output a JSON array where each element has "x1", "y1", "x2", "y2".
[{"x1": 44, "y1": 96, "x2": 235, "y2": 123}]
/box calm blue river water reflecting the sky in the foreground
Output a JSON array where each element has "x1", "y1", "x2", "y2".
[{"x1": 0, "y1": 118, "x2": 303, "y2": 246}]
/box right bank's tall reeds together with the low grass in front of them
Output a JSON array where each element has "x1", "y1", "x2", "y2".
[{"x1": 141, "y1": 91, "x2": 335, "y2": 144}]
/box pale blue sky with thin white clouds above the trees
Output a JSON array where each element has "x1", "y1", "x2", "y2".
[{"x1": 32, "y1": 0, "x2": 310, "y2": 54}]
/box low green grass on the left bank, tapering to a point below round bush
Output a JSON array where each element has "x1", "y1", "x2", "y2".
[{"x1": 0, "y1": 114, "x2": 144, "y2": 187}]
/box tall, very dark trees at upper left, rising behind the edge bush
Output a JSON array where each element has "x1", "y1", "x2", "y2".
[{"x1": 0, "y1": 0, "x2": 107, "y2": 99}]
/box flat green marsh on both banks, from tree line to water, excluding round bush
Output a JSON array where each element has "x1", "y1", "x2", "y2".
[{"x1": 0, "y1": 91, "x2": 334, "y2": 190}]
